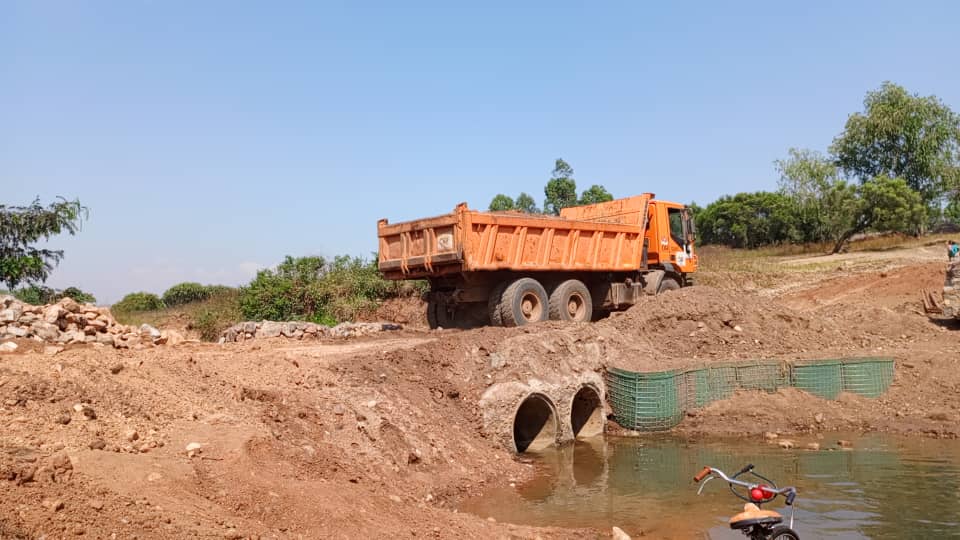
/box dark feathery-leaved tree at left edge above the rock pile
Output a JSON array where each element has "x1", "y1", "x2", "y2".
[{"x1": 0, "y1": 198, "x2": 88, "y2": 289}]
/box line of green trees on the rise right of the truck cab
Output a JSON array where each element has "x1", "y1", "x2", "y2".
[{"x1": 691, "y1": 82, "x2": 960, "y2": 253}]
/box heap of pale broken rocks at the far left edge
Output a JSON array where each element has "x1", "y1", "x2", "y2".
[{"x1": 0, "y1": 295, "x2": 183, "y2": 349}]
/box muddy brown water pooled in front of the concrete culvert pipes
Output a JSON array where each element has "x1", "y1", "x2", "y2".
[{"x1": 461, "y1": 434, "x2": 960, "y2": 540}]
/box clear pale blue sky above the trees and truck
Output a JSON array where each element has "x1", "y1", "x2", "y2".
[{"x1": 0, "y1": 0, "x2": 960, "y2": 302}]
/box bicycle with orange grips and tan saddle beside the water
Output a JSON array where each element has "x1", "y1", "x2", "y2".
[{"x1": 693, "y1": 465, "x2": 800, "y2": 540}]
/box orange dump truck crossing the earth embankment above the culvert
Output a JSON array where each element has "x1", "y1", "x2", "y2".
[{"x1": 377, "y1": 193, "x2": 697, "y2": 328}]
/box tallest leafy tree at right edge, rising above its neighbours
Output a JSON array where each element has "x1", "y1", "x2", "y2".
[{"x1": 830, "y1": 82, "x2": 960, "y2": 203}]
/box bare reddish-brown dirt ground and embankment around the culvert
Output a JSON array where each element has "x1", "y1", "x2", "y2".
[{"x1": 0, "y1": 248, "x2": 960, "y2": 539}]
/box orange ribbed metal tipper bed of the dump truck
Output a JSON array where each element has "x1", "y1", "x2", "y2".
[{"x1": 377, "y1": 193, "x2": 652, "y2": 279}]
